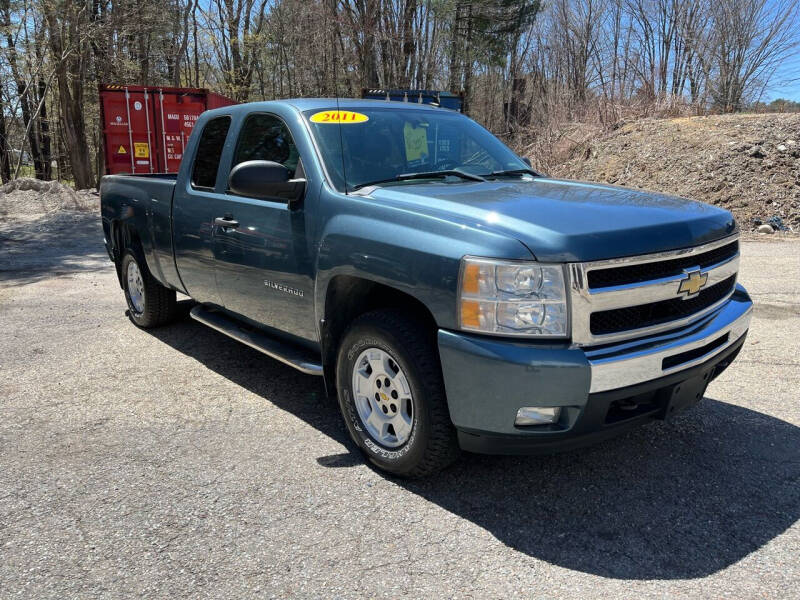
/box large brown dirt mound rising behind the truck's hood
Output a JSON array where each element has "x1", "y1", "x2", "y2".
[{"x1": 550, "y1": 114, "x2": 800, "y2": 232}]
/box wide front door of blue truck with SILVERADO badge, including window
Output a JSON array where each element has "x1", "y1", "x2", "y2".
[{"x1": 214, "y1": 113, "x2": 316, "y2": 341}]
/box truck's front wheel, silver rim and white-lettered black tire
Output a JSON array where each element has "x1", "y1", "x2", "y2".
[{"x1": 336, "y1": 310, "x2": 459, "y2": 477}]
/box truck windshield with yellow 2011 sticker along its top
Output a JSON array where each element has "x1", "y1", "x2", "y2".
[{"x1": 303, "y1": 106, "x2": 529, "y2": 191}]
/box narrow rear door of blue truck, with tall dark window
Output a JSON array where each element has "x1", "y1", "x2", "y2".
[{"x1": 172, "y1": 116, "x2": 231, "y2": 306}]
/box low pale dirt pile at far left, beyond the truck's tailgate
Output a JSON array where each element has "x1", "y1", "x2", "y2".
[{"x1": 0, "y1": 179, "x2": 100, "y2": 221}]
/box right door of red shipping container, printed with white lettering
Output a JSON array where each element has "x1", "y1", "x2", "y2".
[{"x1": 152, "y1": 91, "x2": 205, "y2": 173}]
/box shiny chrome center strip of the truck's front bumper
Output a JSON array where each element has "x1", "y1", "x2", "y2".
[{"x1": 585, "y1": 285, "x2": 753, "y2": 393}]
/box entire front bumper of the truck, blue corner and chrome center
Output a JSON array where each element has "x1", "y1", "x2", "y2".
[{"x1": 439, "y1": 285, "x2": 753, "y2": 454}]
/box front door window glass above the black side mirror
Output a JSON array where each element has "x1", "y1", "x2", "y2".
[{"x1": 231, "y1": 114, "x2": 300, "y2": 173}]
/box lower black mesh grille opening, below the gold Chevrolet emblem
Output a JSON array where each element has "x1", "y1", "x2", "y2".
[{"x1": 589, "y1": 274, "x2": 736, "y2": 335}]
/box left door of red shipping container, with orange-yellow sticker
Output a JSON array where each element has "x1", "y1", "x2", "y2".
[{"x1": 100, "y1": 88, "x2": 158, "y2": 174}]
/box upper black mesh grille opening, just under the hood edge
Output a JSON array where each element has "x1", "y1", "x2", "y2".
[{"x1": 587, "y1": 241, "x2": 739, "y2": 289}]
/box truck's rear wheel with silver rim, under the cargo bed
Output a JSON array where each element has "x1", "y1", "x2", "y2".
[{"x1": 120, "y1": 248, "x2": 177, "y2": 329}]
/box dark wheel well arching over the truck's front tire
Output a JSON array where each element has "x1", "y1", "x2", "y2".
[{"x1": 321, "y1": 275, "x2": 437, "y2": 397}]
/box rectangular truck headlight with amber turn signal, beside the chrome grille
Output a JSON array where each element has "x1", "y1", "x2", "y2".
[{"x1": 458, "y1": 256, "x2": 569, "y2": 337}]
